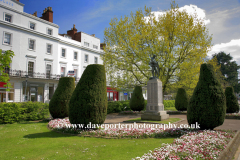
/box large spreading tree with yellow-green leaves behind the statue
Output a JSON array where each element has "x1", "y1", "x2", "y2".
[{"x1": 101, "y1": 1, "x2": 212, "y2": 96}]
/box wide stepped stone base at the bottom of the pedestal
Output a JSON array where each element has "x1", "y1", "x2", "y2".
[{"x1": 141, "y1": 111, "x2": 169, "y2": 121}]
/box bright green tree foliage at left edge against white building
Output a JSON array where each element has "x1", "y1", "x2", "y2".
[{"x1": 0, "y1": 49, "x2": 15, "y2": 91}]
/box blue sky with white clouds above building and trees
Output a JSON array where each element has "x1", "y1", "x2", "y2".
[{"x1": 19, "y1": 0, "x2": 240, "y2": 65}]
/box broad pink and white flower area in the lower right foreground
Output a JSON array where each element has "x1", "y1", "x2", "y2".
[{"x1": 133, "y1": 130, "x2": 235, "y2": 160}]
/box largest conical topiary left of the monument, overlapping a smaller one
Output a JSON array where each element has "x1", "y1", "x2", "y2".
[{"x1": 69, "y1": 64, "x2": 108, "y2": 129}]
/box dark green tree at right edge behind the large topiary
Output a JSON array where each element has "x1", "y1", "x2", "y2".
[{"x1": 212, "y1": 51, "x2": 240, "y2": 93}]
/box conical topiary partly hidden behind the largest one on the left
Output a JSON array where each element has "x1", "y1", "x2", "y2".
[{"x1": 49, "y1": 77, "x2": 75, "y2": 119}]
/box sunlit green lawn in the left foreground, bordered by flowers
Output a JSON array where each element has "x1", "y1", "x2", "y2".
[{"x1": 0, "y1": 122, "x2": 174, "y2": 160}]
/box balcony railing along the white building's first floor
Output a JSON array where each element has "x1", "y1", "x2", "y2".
[{"x1": 5, "y1": 69, "x2": 80, "y2": 82}]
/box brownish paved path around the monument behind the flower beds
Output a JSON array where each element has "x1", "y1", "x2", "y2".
[{"x1": 104, "y1": 113, "x2": 240, "y2": 160}]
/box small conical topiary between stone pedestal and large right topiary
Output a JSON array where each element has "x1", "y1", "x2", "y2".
[{"x1": 175, "y1": 88, "x2": 188, "y2": 111}]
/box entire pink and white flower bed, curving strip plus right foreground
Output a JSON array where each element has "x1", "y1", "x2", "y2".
[{"x1": 48, "y1": 118, "x2": 236, "y2": 160}]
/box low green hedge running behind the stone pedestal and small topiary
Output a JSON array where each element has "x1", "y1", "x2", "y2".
[{"x1": 107, "y1": 100, "x2": 175, "y2": 114}]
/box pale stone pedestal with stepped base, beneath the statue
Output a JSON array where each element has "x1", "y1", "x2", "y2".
[{"x1": 141, "y1": 78, "x2": 169, "y2": 121}]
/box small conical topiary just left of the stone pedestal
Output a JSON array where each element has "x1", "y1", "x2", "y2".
[{"x1": 129, "y1": 86, "x2": 144, "y2": 111}]
